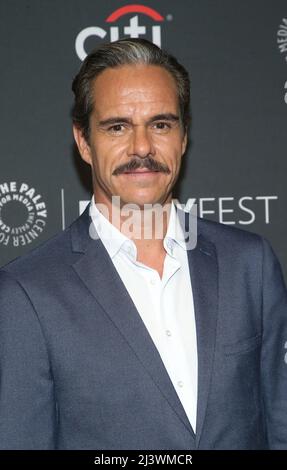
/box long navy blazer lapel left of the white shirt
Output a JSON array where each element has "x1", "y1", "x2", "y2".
[{"x1": 72, "y1": 209, "x2": 194, "y2": 435}]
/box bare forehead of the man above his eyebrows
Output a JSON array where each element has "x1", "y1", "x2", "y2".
[{"x1": 92, "y1": 65, "x2": 178, "y2": 114}]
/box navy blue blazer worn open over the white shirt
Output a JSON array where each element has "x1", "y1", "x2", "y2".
[{"x1": 0, "y1": 209, "x2": 287, "y2": 450}]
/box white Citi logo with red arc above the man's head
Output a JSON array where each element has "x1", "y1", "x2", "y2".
[{"x1": 75, "y1": 5, "x2": 164, "y2": 60}]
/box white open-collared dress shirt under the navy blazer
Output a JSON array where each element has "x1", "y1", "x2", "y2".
[{"x1": 91, "y1": 198, "x2": 198, "y2": 432}]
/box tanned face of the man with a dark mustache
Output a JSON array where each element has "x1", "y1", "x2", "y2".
[{"x1": 74, "y1": 65, "x2": 186, "y2": 207}]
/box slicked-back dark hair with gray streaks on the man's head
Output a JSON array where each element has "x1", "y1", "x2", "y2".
[{"x1": 72, "y1": 38, "x2": 190, "y2": 142}]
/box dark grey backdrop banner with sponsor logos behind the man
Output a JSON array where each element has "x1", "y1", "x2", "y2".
[{"x1": 0, "y1": 0, "x2": 287, "y2": 276}]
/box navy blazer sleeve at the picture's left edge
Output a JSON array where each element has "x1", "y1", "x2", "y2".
[{"x1": 0, "y1": 270, "x2": 56, "y2": 449}]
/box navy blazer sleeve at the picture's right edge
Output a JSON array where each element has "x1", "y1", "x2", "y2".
[{"x1": 261, "y1": 240, "x2": 287, "y2": 449}]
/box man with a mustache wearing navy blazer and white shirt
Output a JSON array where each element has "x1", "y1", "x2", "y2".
[{"x1": 0, "y1": 39, "x2": 287, "y2": 450}]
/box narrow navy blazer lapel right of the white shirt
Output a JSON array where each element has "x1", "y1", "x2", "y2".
[{"x1": 188, "y1": 234, "x2": 218, "y2": 447}]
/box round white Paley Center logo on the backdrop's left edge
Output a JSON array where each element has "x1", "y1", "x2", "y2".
[{"x1": 0, "y1": 181, "x2": 47, "y2": 248}]
